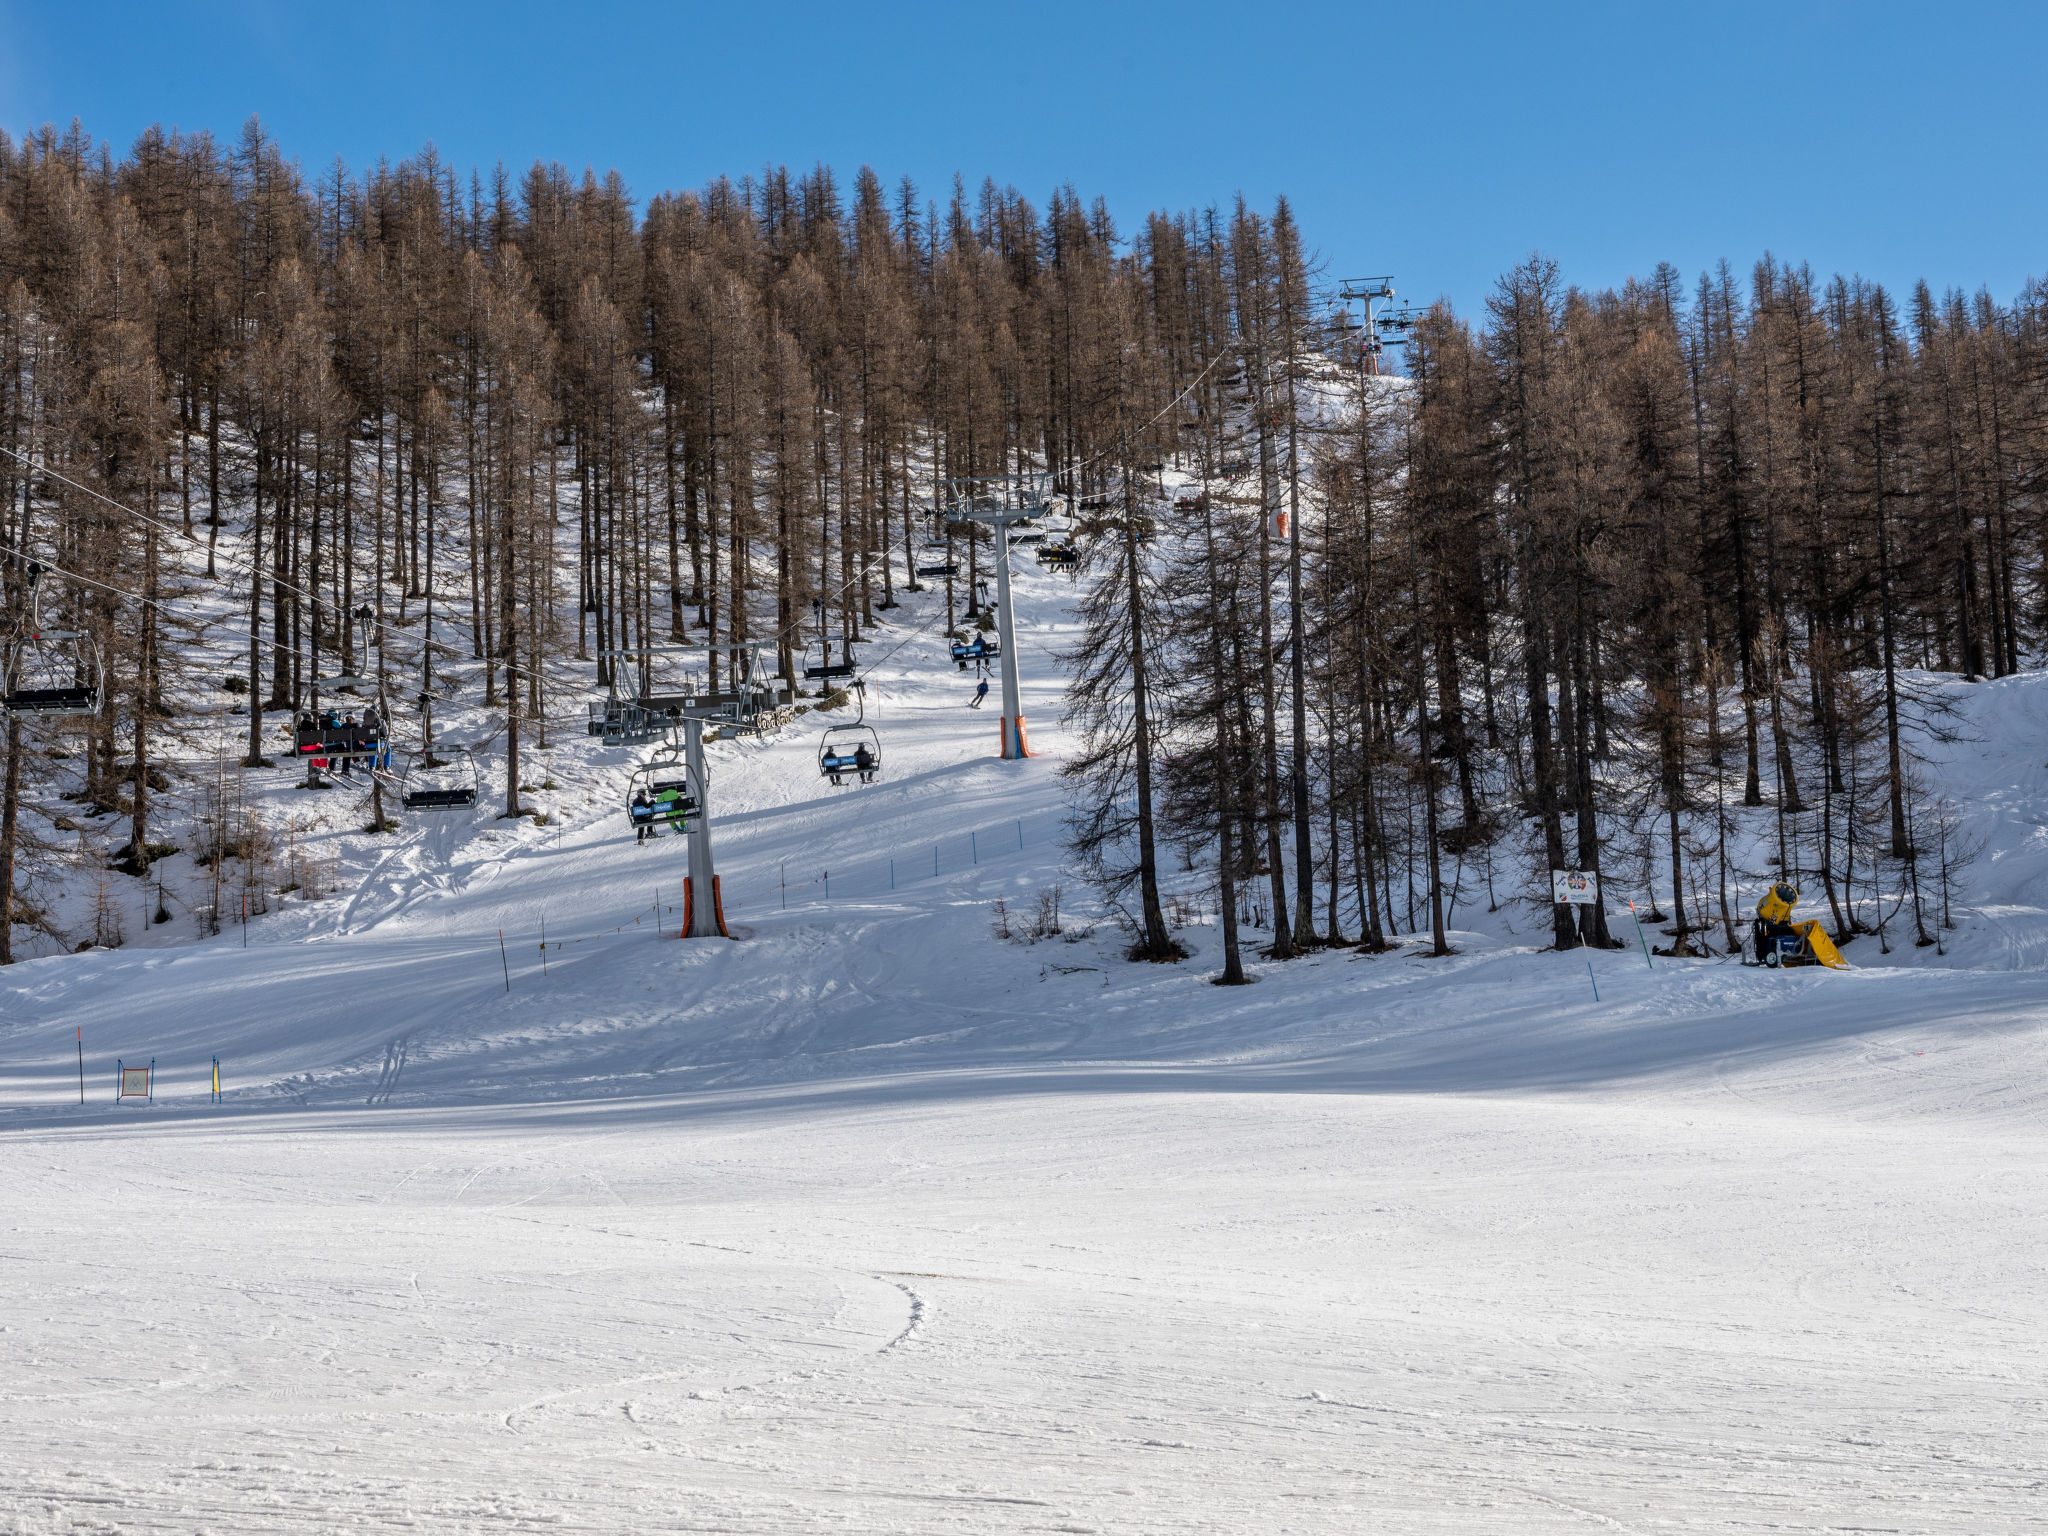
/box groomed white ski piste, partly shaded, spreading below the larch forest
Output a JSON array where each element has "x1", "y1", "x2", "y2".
[{"x1": 0, "y1": 561, "x2": 2048, "y2": 1536}]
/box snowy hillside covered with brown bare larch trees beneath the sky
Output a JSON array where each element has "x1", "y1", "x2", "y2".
[{"x1": 0, "y1": 123, "x2": 2048, "y2": 977}]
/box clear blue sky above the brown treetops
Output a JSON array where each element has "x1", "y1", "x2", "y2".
[{"x1": 0, "y1": 0, "x2": 2048, "y2": 325}]
